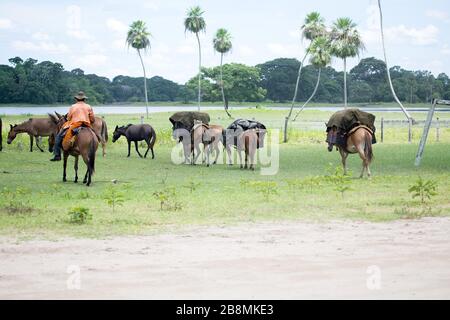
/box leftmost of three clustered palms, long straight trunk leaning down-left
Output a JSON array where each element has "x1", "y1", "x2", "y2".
[{"x1": 284, "y1": 11, "x2": 326, "y2": 142}]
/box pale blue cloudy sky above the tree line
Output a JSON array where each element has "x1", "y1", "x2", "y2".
[{"x1": 0, "y1": 0, "x2": 450, "y2": 83}]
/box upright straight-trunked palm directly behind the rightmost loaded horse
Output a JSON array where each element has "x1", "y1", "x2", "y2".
[{"x1": 331, "y1": 18, "x2": 364, "y2": 108}]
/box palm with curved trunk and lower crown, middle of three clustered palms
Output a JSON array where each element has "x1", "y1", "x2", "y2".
[{"x1": 293, "y1": 36, "x2": 331, "y2": 121}]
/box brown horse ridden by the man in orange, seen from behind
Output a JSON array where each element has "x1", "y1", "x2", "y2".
[{"x1": 52, "y1": 116, "x2": 99, "y2": 187}]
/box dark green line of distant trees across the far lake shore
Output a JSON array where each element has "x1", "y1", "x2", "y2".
[{"x1": 0, "y1": 57, "x2": 450, "y2": 104}]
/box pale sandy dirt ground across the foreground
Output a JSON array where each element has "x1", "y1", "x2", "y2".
[{"x1": 0, "y1": 218, "x2": 450, "y2": 299}]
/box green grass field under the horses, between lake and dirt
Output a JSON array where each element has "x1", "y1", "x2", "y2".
[{"x1": 0, "y1": 109, "x2": 450, "y2": 238}]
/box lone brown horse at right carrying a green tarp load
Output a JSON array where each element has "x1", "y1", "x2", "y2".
[{"x1": 327, "y1": 126, "x2": 373, "y2": 178}]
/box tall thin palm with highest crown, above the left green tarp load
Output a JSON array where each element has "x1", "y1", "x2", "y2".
[{"x1": 184, "y1": 6, "x2": 206, "y2": 111}]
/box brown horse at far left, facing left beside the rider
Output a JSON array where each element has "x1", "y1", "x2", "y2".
[{"x1": 6, "y1": 118, "x2": 56, "y2": 152}]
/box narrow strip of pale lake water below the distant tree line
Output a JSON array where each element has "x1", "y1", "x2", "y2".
[{"x1": 0, "y1": 105, "x2": 450, "y2": 115}]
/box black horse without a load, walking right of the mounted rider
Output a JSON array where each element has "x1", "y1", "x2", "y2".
[{"x1": 113, "y1": 124, "x2": 156, "y2": 159}]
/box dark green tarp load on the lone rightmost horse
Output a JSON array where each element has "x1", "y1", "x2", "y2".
[{"x1": 327, "y1": 109, "x2": 375, "y2": 132}]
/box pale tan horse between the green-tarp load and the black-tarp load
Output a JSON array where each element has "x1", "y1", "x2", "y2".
[{"x1": 191, "y1": 123, "x2": 223, "y2": 167}]
